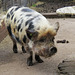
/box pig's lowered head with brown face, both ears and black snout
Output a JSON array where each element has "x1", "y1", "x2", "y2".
[{"x1": 27, "y1": 22, "x2": 59, "y2": 57}]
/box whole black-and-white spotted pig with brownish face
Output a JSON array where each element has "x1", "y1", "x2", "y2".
[{"x1": 2, "y1": 6, "x2": 59, "y2": 66}]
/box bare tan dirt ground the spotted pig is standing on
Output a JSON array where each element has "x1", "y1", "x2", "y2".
[{"x1": 0, "y1": 19, "x2": 75, "y2": 75}]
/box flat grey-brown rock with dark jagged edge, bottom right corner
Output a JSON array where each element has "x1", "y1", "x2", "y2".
[{"x1": 58, "y1": 54, "x2": 75, "y2": 75}]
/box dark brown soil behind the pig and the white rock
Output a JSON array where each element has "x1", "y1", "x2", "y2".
[{"x1": 33, "y1": 0, "x2": 75, "y2": 13}]
